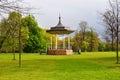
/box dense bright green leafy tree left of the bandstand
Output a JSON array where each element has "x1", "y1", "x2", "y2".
[{"x1": 23, "y1": 15, "x2": 46, "y2": 53}]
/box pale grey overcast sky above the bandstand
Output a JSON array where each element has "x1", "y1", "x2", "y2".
[{"x1": 26, "y1": 0, "x2": 108, "y2": 33}]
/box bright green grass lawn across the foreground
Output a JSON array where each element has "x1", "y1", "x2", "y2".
[{"x1": 0, "y1": 52, "x2": 120, "y2": 80}]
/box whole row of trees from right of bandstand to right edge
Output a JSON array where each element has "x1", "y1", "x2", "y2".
[{"x1": 72, "y1": 21, "x2": 120, "y2": 52}]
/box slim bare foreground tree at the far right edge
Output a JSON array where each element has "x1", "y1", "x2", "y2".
[{"x1": 102, "y1": 0, "x2": 120, "y2": 63}]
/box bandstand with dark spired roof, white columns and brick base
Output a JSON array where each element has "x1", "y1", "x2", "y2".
[{"x1": 46, "y1": 16, "x2": 74, "y2": 55}]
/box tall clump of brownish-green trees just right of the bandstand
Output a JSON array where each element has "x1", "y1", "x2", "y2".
[{"x1": 72, "y1": 21, "x2": 100, "y2": 52}]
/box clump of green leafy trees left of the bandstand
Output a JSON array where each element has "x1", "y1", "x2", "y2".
[{"x1": 0, "y1": 12, "x2": 49, "y2": 53}]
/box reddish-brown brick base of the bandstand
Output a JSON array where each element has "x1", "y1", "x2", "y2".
[{"x1": 47, "y1": 49, "x2": 73, "y2": 55}]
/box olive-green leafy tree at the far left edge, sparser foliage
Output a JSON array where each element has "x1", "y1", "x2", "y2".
[{"x1": 1, "y1": 12, "x2": 22, "y2": 52}]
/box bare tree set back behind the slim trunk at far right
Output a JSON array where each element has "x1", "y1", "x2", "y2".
[{"x1": 102, "y1": 11, "x2": 116, "y2": 51}]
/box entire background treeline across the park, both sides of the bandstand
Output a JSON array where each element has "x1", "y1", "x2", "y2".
[{"x1": 0, "y1": 12, "x2": 120, "y2": 53}]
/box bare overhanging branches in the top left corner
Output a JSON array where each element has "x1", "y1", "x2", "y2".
[{"x1": 0, "y1": 0, "x2": 29, "y2": 15}]
